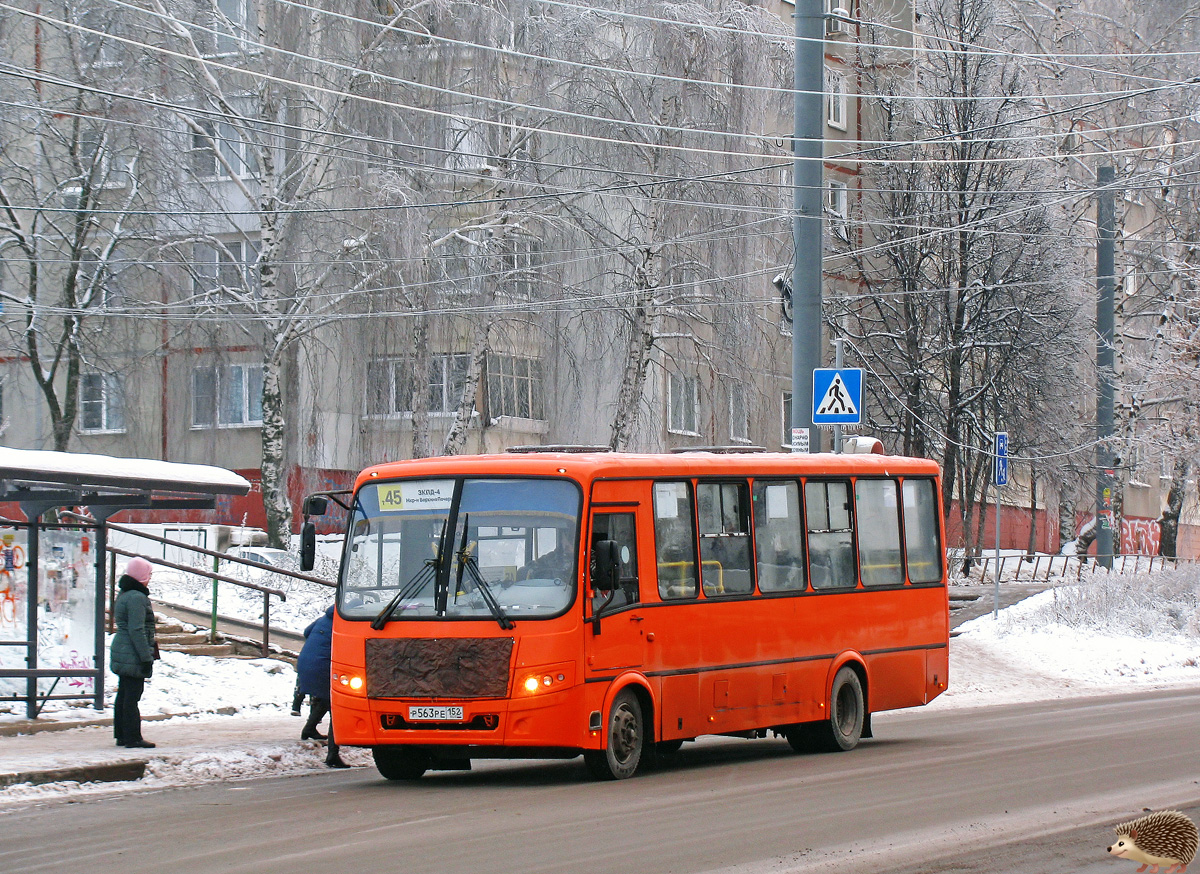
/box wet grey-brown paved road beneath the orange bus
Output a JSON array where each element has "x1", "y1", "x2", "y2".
[{"x1": 0, "y1": 692, "x2": 1200, "y2": 874}]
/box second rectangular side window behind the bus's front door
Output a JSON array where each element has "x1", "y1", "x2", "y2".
[{"x1": 696, "y1": 483, "x2": 754, "y2": 595}]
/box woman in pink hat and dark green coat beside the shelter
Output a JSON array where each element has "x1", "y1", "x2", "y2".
[{"x1": 109, "y1": 556, "x2": 158, "y2": 748}]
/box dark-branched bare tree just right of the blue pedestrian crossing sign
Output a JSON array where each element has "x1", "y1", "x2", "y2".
[{"x1": 836, "y1": 0, "x2": 1080, "y2": 559}]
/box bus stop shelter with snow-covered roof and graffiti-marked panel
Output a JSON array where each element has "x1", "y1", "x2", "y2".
[{"x1": 0, "y1": 447, "x2": 250, "y2": 719}]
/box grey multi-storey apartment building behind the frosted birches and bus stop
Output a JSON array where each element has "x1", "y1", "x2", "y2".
[{"x1": 0, "y1": 0, "x2": 911, "y2": 535}]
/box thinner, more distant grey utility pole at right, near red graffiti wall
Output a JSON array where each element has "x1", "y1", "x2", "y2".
[{"x1": 1096, "y1": 167, "x2": 1116, "y2": 570}]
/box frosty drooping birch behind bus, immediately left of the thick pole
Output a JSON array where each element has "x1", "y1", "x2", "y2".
[{"x1": 532, "y1": 2, "x2": 790, "y2": 449}]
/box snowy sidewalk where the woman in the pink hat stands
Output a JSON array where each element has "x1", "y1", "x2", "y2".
[{"x1": 0, "y1": 707, "x2": 350, "y2": 791}]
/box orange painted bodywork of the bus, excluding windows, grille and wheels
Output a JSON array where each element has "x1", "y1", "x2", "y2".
[{"x1": 331, "y1": 453, "x2": 949, "y2": 756}]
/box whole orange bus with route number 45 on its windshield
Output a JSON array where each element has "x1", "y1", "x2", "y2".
[{"x1": 301, "y1": 444, "x2": 949, "y2": 780}]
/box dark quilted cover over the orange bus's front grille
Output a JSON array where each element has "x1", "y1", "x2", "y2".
[{"x1": 366, "y1": 637, "x2": 512, "y2": 699}]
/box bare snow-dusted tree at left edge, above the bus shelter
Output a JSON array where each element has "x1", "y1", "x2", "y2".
[{"x1": 0, "y1": 2, "x2": 156, "y2": 450}]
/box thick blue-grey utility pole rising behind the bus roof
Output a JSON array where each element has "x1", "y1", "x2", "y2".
[{"x1": 791, "y1": 0, "x2": 824, "y2": 453}]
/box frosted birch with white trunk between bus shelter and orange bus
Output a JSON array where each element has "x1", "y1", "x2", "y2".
[{"x1": 124, "y1": 0, "x2": 465, "y2": 545}]
